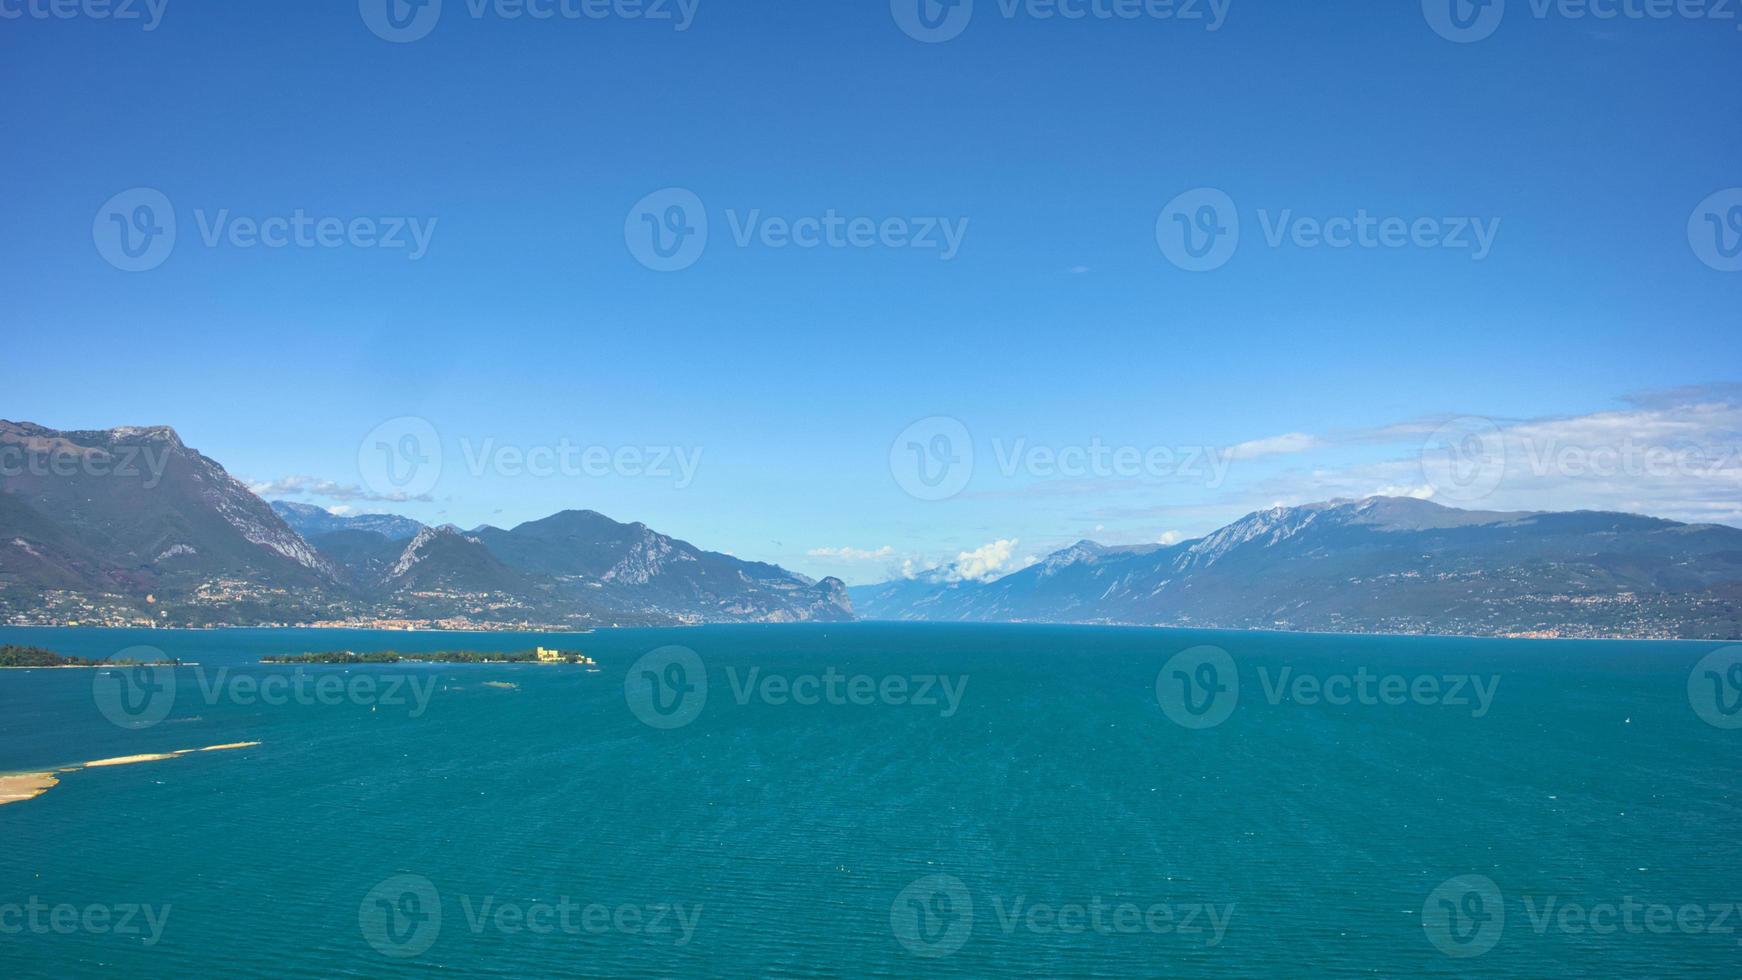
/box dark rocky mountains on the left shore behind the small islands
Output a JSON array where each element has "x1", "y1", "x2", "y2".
[{"x1": 0, "y1": 421, "x2": 852, "y2": 628}]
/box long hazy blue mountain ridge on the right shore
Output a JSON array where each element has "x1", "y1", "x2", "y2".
[{"x1": 850, "y1": 498, "x2": 1742, "y2": 639}]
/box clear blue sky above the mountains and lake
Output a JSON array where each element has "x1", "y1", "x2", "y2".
[{"x1": 0, "y1": 0, "x2": 1742, "y2": 581}]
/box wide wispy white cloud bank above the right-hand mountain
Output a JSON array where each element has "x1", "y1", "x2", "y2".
[{"x1": 1078, "y1": 385, "x2": 1742, "y2": 536}]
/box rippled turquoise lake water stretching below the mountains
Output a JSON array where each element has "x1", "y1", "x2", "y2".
[{"x1": 0, "y1": 623, "x2": 1742, "y2": 978}]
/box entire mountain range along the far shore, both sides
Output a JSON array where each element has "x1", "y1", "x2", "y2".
[{"x1": 0, "y1": 421, "x2": 1742, "y2": 639}]
